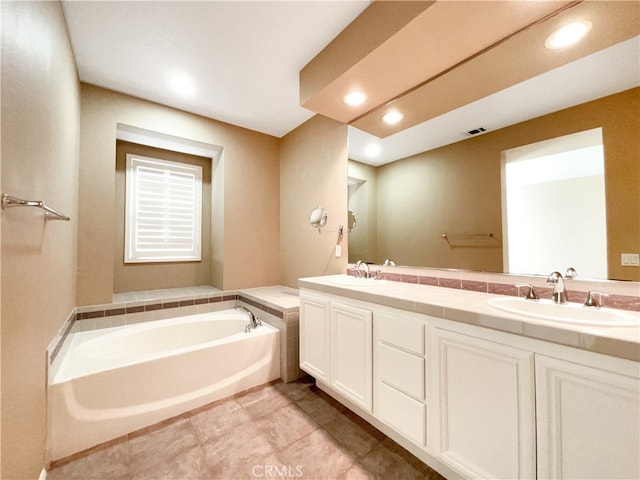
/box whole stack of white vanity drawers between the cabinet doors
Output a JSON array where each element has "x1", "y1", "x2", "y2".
[{"x1": 373, "y1": 309, "x2": 427, "y2": 448}]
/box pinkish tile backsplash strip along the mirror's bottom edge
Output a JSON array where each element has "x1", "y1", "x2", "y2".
[{"x1": 347, "y1": 265, "x2": 640, "y2": 312}]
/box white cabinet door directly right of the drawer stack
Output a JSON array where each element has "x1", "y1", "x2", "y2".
[{"x1": 427, "y1": 328, "x2": 536, "y2": 480}]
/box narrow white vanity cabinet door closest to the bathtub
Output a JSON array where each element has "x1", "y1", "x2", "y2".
[{"x1": 300, "y1": 295, "x2": 331, "y2": 383}]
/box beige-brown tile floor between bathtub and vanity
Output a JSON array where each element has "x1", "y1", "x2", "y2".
[{"x1": 47, "y1": 377, "x2": 443, "y2": 480}]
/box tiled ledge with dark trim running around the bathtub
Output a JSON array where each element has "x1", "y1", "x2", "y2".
[{"x1": 47, "y1": 286, "x2": 301, "y2": 381}]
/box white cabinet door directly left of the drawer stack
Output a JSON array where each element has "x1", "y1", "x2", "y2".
[{"x1": 331, "y1": 302, "x2": 372, "y2": 412}]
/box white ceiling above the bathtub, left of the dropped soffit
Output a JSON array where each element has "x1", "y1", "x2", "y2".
[{"x1": 63, "y1": 0, "x2": 369, "y2": 137}]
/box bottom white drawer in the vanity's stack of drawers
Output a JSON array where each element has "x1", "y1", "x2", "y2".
[{"x1": 374, "y1": 381, "x2": 426, "y2": 446}]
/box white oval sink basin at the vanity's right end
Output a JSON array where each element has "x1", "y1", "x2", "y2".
[{"x1": 487, "y1": 297, "x2": 640, "y2": 327}]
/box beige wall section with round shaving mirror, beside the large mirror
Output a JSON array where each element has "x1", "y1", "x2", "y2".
[{"x1": 280, "y1": 115, "x2": 348, "y2": 288}]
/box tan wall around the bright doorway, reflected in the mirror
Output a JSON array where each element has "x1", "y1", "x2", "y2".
[{"x1": 377, "y1": 88, "x2": 640, "y2": 280}]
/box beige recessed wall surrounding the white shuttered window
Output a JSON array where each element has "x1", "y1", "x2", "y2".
[{"x1": 113, "y1": 140, "x2": 212, "y2": 293}]
